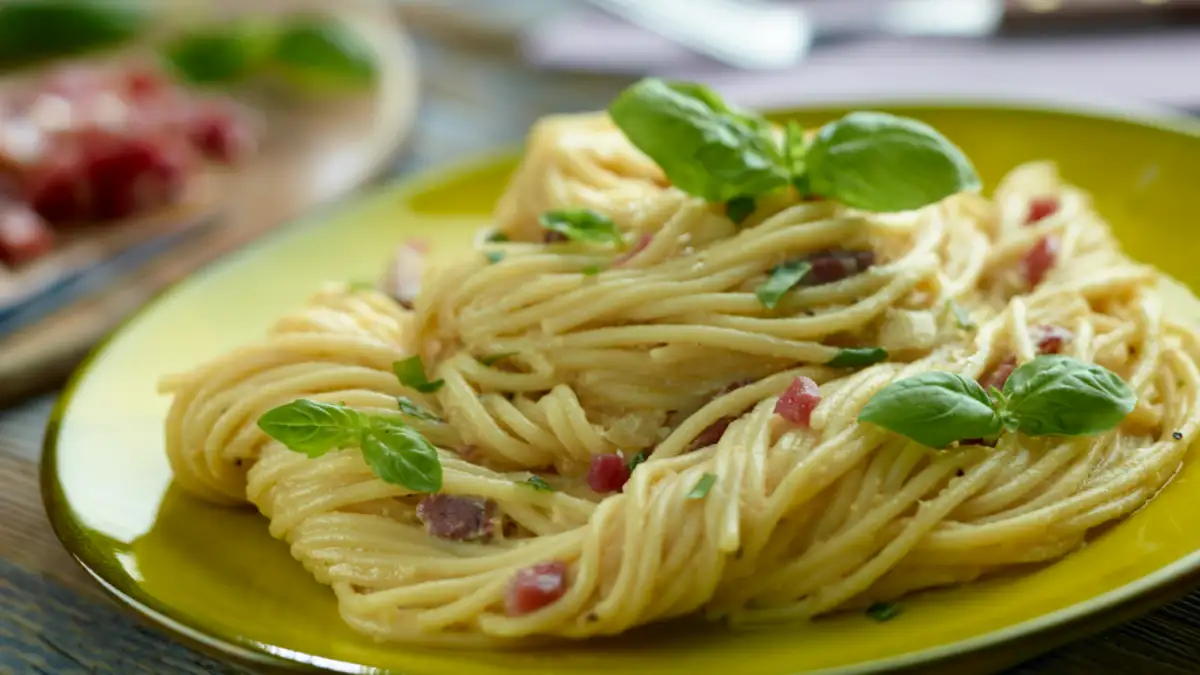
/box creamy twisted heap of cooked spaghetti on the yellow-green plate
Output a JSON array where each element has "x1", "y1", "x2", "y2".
[{"x1": 163, "y1": 105, "x2": 1200, "y2": 644}]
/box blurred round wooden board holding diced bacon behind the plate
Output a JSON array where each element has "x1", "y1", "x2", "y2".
[{"x1": 0, "y1": 0, "x2": 419, "y2": 407}]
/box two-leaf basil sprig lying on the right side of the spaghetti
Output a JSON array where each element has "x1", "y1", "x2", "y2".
[{"x1": 858, "y1": 354, "x2": 1138, "y2": 448}]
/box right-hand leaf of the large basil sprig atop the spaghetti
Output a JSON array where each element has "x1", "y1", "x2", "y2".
[{"x1": 805, "y1": 112, "x2": 979, "y2": 211}]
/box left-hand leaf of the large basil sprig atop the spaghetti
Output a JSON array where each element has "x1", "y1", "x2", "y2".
[{"x1": 608, "y1": 78, "x2": 788, "y2": 203}]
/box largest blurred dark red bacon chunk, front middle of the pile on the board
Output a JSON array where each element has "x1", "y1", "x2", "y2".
[{"x1": 80, "y1": 132, "x2": 191, "y2": 220}]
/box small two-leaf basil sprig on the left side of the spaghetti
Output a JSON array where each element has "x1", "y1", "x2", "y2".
[{"x1": 258, "y1": 399, "x2": 442, "y2": 492}]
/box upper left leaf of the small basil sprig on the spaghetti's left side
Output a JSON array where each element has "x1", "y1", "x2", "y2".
[{"x1": 258, "y1": 399, "x2": 365, "y2": 458}]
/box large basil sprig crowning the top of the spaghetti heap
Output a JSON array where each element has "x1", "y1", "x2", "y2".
[{"x1": 608, "y1": 78, "x2": 979, "y2": 211}]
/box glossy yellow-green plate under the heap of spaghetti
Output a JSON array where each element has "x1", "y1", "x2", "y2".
[{"x1": 42, "y1": 106, "x2": 1200, "y2": 675}]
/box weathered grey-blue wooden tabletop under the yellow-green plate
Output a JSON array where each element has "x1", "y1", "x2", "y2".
[{"x1": 0, "y1": 28, "x2": 1200, "y2": 675}]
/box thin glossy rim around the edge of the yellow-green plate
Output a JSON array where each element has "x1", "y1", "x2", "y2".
[{"x1": 38, "y1": 96, "x2": 1200, "y2": 675}]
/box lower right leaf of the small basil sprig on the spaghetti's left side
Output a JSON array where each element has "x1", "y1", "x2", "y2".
[{"x1": 361, "y1": 418, "x2": 442, "y2": 494}]
